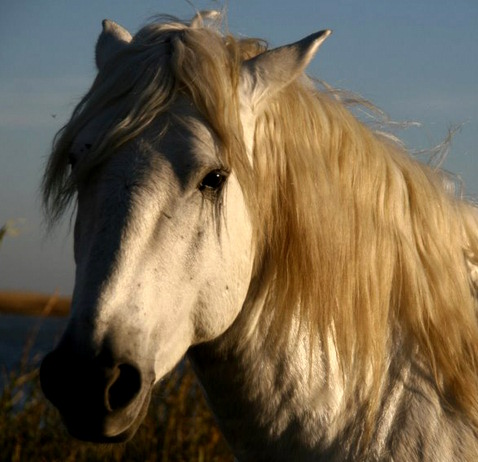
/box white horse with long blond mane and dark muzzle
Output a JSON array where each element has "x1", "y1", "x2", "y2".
[{"x1": 40, "y1": 12, "x2": 478, "y2": 462}]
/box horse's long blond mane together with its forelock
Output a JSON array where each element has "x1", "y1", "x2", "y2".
[{"x1": 43, "y1": 18, "x2": 478, "y2": 434}]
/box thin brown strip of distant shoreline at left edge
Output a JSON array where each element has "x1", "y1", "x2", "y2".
[{"x1": 0, "y1": 291, "x2": 71, "y2": 317}]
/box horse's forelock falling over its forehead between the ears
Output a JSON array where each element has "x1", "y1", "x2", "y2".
[{"x1": 42, "y1": 16, "x2": 266, "y2": 224}]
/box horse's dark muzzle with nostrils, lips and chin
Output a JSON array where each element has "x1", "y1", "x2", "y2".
[{"x1": 40, "y1": 346, "x2": 153, "y2": 443}]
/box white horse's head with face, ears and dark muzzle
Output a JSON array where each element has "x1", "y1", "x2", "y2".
[{"x1": 40, "y1": 13, "x2": 328, "y2": 442}]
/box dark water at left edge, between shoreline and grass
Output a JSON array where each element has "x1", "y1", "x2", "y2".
[{"x1": 0, "y1": 314, "x2": 67, "y2": 390}]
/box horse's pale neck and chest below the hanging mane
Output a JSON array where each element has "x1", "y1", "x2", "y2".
[{"x1": 188, "y1": 298, "x2": 478, "y2": 461}]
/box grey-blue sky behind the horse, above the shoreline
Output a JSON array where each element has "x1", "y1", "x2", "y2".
[{"x1": 0, "y1": 0, "x2": 478, "y2": 295}]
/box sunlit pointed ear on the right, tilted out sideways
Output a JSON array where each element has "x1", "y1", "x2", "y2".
[{"x1": 241, "y1": 30, "x2": 332, "y2": 111}]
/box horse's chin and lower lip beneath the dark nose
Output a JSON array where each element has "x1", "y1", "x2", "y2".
[{"x1": 62, "y1": 392, "x2": 151, "y2": 444}]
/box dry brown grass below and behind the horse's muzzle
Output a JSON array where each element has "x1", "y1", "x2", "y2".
[{"x1": 0, "y1": 352, "x2": 233, "y2": 462}]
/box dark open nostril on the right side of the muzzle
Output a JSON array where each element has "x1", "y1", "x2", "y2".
[{"x1": 105, "y1": 364, "x2": 141, "y2": 411}]
